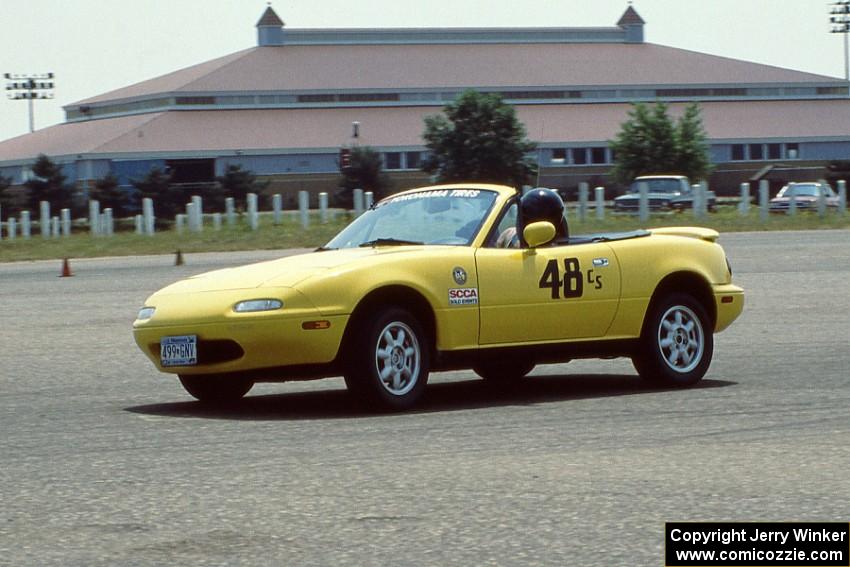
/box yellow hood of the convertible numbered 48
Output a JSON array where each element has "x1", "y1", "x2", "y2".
[{"x1": 158, "y1": 246, "x2": 430, "y2": 294}]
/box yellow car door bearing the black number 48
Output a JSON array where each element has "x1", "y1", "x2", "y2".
[{"x1": 476, "y1": 236, "x2": 620, "y2": 345}]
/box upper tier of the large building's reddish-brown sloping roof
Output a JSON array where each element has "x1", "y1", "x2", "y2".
[{"x1": 71, "y1": 43, "x2": 846, "y2": 108}]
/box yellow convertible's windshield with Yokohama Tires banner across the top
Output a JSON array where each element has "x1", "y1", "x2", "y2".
[{"x1": 323, "y1": 188, "x2": 497, "y2": 249}]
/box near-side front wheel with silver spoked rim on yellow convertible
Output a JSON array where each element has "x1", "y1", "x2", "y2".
[{"x1": 344, "y1": 307, "x2": 431, "y2": 411}]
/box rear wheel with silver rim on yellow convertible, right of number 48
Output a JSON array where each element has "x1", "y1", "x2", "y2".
[{"x1": 632, "y1": 293, "x2": 714, "y2": 386}]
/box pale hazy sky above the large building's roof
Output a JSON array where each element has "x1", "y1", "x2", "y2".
[{"x1": 0, "y1": 0, "x2": 844, "y2": 140}]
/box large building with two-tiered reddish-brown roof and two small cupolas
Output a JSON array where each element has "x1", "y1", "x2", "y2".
[{"x1": 0, "y1": 6, "x2": 850, "y2": 203}]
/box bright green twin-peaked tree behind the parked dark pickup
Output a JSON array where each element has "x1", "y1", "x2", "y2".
[{"x1": 609, "y1": 102, "x2": 711, "y2": 184}]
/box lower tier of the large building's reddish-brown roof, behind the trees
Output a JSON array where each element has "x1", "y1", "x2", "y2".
[{"x1": 0, "y1": 100, "x2": 850, "y2": 163}]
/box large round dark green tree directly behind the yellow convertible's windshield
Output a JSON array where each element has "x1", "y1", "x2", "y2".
[{"x1": 422, "y1": 90, "x2": 537, "y2": 187}]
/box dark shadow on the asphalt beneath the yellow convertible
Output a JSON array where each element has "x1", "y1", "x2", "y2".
[{"x1": 125, "y1": 374, "x2": 737, "y2": 421}]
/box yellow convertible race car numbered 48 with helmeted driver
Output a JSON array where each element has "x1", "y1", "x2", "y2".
[{"x1": 133, "y1": 184, "x2": 744, "y2": 410}]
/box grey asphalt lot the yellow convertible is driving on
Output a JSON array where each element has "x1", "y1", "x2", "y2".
[{"x1": 0, "y1": 231, "x2": 850, "y2": 566}]
